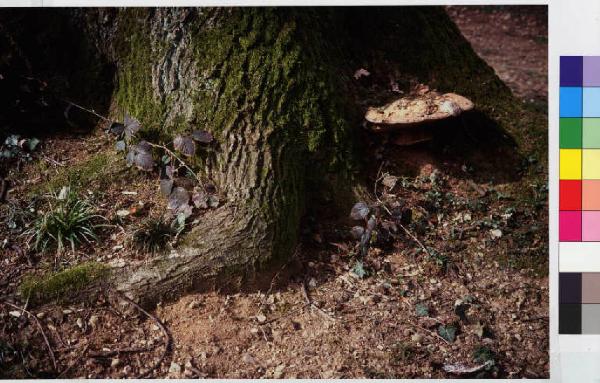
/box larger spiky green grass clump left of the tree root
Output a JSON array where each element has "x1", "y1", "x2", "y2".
[{"x1": 28, "y1": 188, "x2": 104, "y2": 254}]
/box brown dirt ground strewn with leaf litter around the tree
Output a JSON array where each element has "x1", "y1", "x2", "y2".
[{"x1": 0, "y1": 7, "x2": 549, "y2": 378}]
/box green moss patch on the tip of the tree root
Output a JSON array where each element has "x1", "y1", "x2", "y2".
[{"x1": 19, "y1": 262, "x2": 109, "y2": 302}]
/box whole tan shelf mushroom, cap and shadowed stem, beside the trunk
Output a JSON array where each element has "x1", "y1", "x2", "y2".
[{"x1": 365, "y1": 90, "x2": 474, "y2": 146}]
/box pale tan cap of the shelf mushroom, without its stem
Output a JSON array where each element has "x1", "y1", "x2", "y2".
[{"x1": 365, "y1": 92, "x2": 474, "y2": 131}]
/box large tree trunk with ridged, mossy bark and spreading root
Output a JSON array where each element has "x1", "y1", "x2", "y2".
[{"x1": 3, "y1": 7, "x2": 518, "y2": 304}]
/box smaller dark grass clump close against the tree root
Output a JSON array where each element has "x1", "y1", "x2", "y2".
[{"x1": 133, "y1": 215, "x2": 179, "y2": 253}]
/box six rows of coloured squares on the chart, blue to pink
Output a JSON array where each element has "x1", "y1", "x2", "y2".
[{"x1": 559, "y1": 56, "x2": 600, "y2": 242}]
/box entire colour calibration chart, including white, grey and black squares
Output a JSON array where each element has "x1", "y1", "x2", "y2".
[{"x1": 559, "y1": 56, "x2": 600, "y2": 334}]
